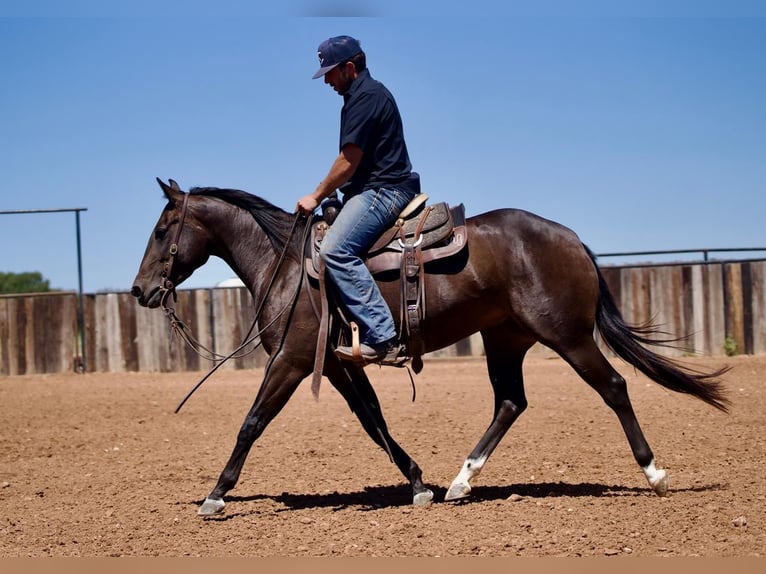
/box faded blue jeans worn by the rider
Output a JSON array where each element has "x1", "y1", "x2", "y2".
[{"x1": 319, "y1": 187, "x2": 414, "y2": 345}]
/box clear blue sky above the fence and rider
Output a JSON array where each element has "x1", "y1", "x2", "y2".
[{"x1": 0, "y1": 0, "x2": 766, "y2": 292}]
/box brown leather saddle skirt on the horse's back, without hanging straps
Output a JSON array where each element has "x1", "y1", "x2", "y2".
[{"x1": 306, "y1": 202, "x2": 468, "y2": 279}]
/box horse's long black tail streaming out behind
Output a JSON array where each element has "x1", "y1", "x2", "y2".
[{"x1": 585, "y1": 247, "x2": 731, "y2": 412}]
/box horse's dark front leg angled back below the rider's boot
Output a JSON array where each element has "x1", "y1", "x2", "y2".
[{"x1": 325, "y1": 356, "x2": 434, "y2": 506}]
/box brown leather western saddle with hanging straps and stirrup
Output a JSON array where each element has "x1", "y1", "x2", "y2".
[{"x1": 305, "y1": 194, "x2": 468, "y2": 397}]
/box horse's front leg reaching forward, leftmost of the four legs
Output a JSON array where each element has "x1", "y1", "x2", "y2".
[{"x1": 197, "y1": 357, "x2": 308, "y2": 516}]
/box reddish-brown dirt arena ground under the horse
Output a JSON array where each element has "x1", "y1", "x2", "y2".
[{"x1": 0, "y1": 356, "x2": 766, "y2": 558}]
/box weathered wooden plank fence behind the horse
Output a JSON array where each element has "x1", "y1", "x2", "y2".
[{"x1": 0, "y1": 261, "x2": 766, "y2": 375}]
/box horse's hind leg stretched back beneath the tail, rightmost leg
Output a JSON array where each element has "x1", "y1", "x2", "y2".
[{"x1": 560, "y1": 337, "x2": 669, "y2": 496}]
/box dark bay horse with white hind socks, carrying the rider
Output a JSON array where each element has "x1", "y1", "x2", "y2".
[{"x1": 131, "y1": 179, "x2": 728, "y2": 516}]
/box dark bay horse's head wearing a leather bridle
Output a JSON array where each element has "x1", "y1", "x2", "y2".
[{"x1": 130, "y1": 178, "x2": 209, "y2": 307}]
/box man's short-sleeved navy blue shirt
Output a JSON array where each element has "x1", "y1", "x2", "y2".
[{"x1": 340, "y1": 69, "x2": 420, "y2": 197}]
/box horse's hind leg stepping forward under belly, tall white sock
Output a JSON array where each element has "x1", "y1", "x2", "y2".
[{"x1": 444, "y1": 327, "x2": 534, "y2": 501}]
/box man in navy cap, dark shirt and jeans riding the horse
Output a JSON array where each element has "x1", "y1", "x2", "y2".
[{"x1": 296, "y1": 36, "x2": 420, "y2": 364}]
